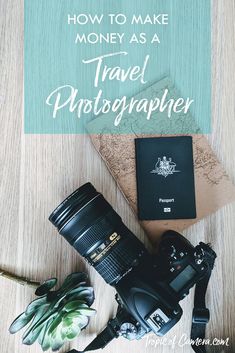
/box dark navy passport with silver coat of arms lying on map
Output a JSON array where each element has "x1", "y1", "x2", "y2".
[{"x1": 135, "y1": 136, "x2": 196, "y2": 220}]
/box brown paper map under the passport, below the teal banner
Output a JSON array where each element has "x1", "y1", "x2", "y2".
[{"x1": 88, "y1": 78, "x2": 235, "y2": 241}]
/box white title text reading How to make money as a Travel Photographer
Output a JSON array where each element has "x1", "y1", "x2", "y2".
[{"x1": 46, "y1": 14, "x2": 194, "y2": 126}]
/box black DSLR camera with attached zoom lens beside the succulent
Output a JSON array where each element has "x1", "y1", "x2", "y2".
[{"x1": 49, "y1": 183, "x2": 216, "y2": 351}]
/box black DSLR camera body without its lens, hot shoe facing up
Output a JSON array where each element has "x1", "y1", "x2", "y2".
[{"x1": 112, "y1": 231, "x2": 215, "y2": 339}]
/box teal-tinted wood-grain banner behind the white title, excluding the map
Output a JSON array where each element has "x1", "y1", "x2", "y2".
[{"x1": 25, "y1": 0, "x2": 211, "y2": 133}]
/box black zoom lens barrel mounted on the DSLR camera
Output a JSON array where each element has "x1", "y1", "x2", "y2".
[{"x1": 49, "y1": 183, "x2": 146, "y2": 285}]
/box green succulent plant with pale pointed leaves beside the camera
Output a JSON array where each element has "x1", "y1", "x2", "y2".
[{"x1": 9, "y1": 272, "x2": 96, "y2": 351}]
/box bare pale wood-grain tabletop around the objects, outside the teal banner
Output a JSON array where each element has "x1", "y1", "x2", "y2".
[{"x1": 0, "y1": 0, "x2": 235, "y2": 353}]
